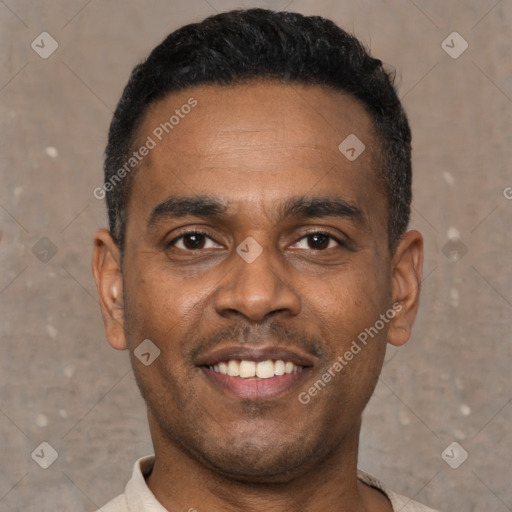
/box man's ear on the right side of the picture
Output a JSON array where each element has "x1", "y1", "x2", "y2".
[{"x1": 388, "y1": 231, "x2": 423, "y2": 347}]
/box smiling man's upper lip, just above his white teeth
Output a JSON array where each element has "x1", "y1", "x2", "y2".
[{"x1": 196, "y1": 345, "x2": 315, "y2": 366}]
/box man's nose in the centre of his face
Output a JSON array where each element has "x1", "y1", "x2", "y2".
[{"x1": 215, "y1": 239, "x2": 301, "y2": 322}]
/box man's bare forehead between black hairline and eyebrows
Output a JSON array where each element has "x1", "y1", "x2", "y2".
[{"x1": 131, "y1": 81, "x2": 380, "y2": 221}]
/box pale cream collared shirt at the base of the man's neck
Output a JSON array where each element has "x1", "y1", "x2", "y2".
[{"x1": 96, "y1": 455, "x2": 436, "y2": 512}]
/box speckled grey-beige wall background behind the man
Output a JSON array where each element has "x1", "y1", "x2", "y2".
[{"x1": 0, "y1": 0, "x2": 512, "y2": 512}]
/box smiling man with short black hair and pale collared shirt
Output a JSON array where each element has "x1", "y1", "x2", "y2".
[{"x1": 93, "y1": 9, "x2": 431, "y2": 512}]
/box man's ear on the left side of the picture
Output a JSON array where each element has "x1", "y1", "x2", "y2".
[{"x1": 92, "y1": 229, "x2": 127, "y2": 350}]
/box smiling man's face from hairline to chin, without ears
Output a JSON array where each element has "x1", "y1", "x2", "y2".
[{"x1": 107, "y1": 82, "x2": 404, "y2": 480}]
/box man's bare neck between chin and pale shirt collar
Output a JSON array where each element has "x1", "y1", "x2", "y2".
[{"x1": 146, "y1": 415, "x2": 392, "y2": 512}]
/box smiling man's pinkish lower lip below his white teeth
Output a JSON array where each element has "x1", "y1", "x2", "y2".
[{"x1": 201, "y1": 366, "x2": 311, "y2": 400}]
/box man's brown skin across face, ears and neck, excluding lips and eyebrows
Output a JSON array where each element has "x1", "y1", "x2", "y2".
[{"x1": 93, "y1": 81, "x2": 423, "y2": 512}]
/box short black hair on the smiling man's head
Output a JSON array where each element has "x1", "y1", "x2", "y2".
[{"x1": 104, "y1": 8, "x2": 412, "y2": 254}]
